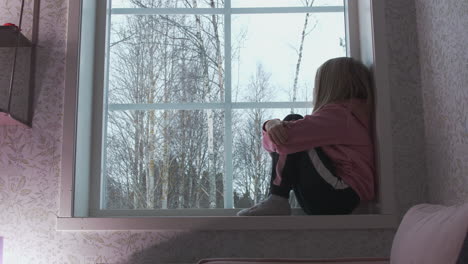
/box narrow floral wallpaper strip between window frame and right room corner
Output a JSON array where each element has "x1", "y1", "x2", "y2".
[{"x1": 385, "y1": 1, "x2": 427, "y2": 216}]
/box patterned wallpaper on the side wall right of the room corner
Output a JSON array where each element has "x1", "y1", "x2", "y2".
[{"x1": 416, "y1": 0, "x2": 468, "y2": 205}]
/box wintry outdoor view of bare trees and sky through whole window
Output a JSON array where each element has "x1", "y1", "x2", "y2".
[{"x1": 101, "y1": 0, "x2": 346, "y2": 212}]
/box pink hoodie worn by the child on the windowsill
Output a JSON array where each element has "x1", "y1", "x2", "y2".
[{"x1": 263, "y1": 99, "x2": 375, "y2": 201}]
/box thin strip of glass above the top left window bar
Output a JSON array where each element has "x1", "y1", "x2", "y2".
[{"x1": 112, "y1": 0, "x2": 224, "y2": 8}]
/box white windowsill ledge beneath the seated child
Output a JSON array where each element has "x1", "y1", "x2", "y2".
[{"x1": 57, "y1": 215, "x2": 398, "y2": 231}]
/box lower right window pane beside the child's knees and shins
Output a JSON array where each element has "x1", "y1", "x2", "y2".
[{"x1": 232, "y1": 108, "x2": 312, "y2": 208}]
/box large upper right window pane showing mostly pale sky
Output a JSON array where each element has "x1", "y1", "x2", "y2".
[{"x1": 232, "y1": 13, "x2": 346, "y2": 102}]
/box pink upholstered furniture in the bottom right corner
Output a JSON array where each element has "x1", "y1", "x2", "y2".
[{"x1": 198, "y1": 203, "x2": 468, "y2": 264}]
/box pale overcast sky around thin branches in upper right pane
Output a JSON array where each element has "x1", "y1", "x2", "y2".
[{"x1": 232, "y1": 13, "x2": 346, "y2": 101}]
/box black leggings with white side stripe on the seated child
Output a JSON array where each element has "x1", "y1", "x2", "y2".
[{"x1": 270, "y1": 114, "x2": 360, "y2": 215}]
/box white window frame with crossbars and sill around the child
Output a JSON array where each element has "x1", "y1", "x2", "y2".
[{"x1": 57, "y1": 0, "x2": 397, "y2": 230}]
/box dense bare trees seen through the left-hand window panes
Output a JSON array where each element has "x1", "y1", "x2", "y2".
[{"x1": 107, "y1": 0, "x2": 224, "y2": 209}]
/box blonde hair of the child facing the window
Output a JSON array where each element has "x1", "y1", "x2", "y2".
[{"x1": 314, "y1": 57, "x2": 374, "y2": 112}]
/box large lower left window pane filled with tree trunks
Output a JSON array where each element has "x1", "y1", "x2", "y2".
[{"x1": 105, "y1": 110, "x2": 224, "y2": 209}]
